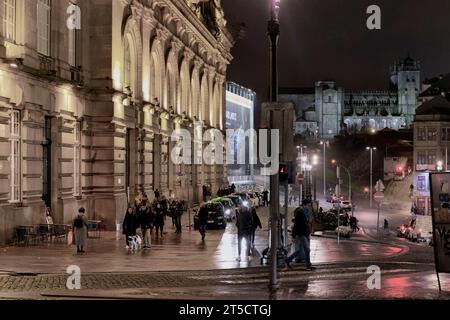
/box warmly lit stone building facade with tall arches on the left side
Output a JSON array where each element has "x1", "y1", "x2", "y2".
[{"x1": 0, "y1": 0, "x2": 233, "y2": 244}]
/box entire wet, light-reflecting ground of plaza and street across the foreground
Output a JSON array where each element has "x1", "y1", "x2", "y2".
[{"x1": 0, "y1": 209, "x2": 450, "y2": 300}]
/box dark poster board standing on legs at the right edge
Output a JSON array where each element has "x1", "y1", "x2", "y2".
[{"x1": 430, "y1": 173, "x2": 450, "y2": 273}]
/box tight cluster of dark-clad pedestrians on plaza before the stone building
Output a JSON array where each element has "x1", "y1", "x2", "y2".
[{"x1": 122, "y1": 190, "x2": 184, "y2": 249}]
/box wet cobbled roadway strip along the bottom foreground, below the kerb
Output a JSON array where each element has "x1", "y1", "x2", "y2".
[{"x1": 0, "y1": 262, "x2": 450, "y2": 300}]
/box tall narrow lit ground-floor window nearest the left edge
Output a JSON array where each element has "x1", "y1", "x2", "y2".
[{"x1": 10, "y1": 110, "x2": 21, "y2": 202}]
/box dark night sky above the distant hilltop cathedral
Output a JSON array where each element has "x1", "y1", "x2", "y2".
[{"x1": 222, "y1": 0, "x2": 450, "y2": 121}]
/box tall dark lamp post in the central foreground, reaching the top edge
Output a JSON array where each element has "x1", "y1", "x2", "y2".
[{"x1": 267, "y1": 0, "x2": 280, "y2": 290}]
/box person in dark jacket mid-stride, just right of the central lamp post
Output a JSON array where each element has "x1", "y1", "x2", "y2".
[{"x1": 286, "y1": 200, "x2": 316, "y2": 271}]
